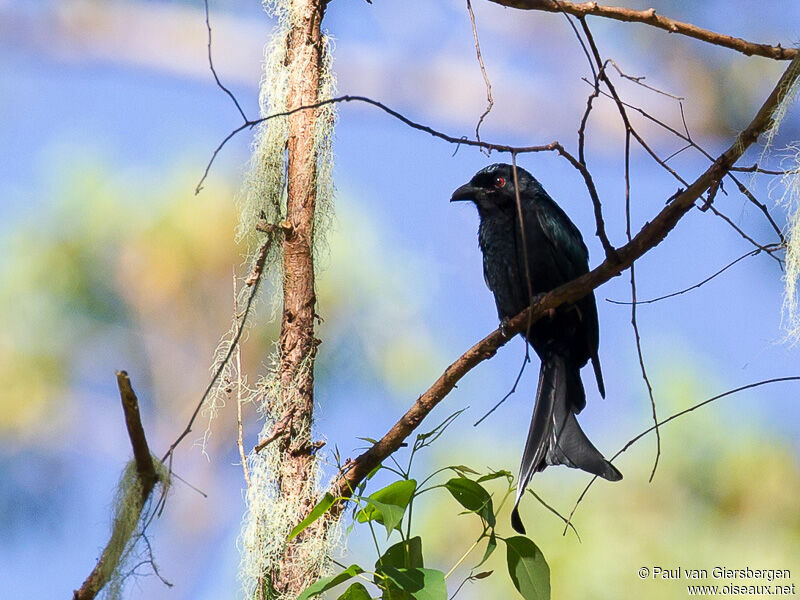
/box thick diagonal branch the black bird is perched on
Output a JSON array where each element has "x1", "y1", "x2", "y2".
[{"x1": 332, "y1": 55, "x2": 800, "y2": 511}]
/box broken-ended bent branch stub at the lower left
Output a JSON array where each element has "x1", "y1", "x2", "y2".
[{"x1": 72, "y1": 371, "x2": 158, "y2": 600}]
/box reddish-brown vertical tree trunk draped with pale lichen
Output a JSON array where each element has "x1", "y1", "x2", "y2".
[{"x1": 270, "y1": 0, "x2": 327, "y2": 596}]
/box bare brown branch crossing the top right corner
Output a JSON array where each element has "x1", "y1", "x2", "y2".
[{"x1": 490, "y1": 0, "x2": 798, "y2": 60}]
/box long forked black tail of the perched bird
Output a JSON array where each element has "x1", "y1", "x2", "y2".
[{"x1": 511, "y1": 354, "x2": 622, "y2": 533}]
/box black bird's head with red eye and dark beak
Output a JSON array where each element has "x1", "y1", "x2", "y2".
[{"x1": 450, "y1": 163, "x2": 541, "y2": 213}]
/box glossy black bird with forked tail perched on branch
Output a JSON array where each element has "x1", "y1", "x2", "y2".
[{"x1": 451, "y1": 164, "x2": 622, "y2": 533}]
